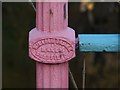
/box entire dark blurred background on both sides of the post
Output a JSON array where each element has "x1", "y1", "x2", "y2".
[{"x1": 2, "y1": 2, "x2": 120, "y2": 88}]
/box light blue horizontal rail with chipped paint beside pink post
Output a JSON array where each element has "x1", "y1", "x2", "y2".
[{"x1": 79, "y1": 34, "x2": 120, "y2": 52}]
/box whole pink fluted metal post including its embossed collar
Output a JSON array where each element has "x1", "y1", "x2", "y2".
[{"x1": 29, "y1": 0, "x2": 75, "y2": 88}]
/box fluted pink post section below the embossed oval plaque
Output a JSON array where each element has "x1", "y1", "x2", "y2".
[{"x1": 36, "y1": 62, "x2": 69, "y2": 90}]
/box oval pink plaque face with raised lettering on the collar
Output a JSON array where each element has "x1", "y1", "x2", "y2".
[{"x1": 29, "y1": 38, "x2": 74, "y2": 63}]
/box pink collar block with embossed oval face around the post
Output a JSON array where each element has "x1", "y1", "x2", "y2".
[{"x1": 29, "y1": 27, "x2": 75, "y2": 64}]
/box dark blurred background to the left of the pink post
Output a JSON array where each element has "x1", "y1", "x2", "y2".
[{"x1": 2, "y1": 2, "x2": 35, "y2": 88}]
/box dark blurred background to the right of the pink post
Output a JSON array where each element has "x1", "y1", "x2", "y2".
[{"x1": 69, "y1": 2, "x2": 120, "y2": 88}]
